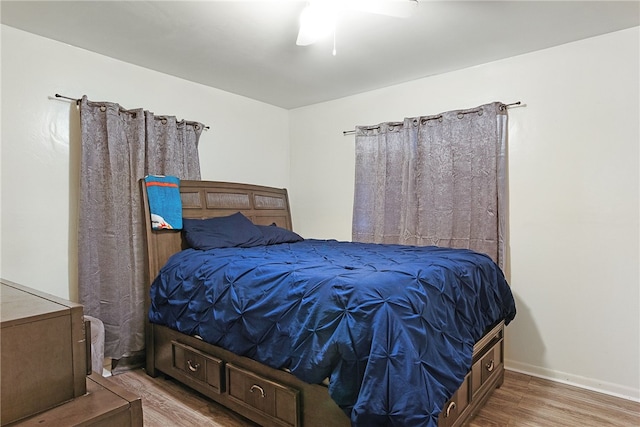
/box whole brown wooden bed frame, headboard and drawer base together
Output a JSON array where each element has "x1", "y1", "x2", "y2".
[{"x1": 140, "y1": 180, "x2": 504, "y2": 427}]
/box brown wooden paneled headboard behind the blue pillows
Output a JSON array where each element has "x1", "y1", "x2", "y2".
[{"x1": 140, "y1": 179, "x2": 292, "y2": 286}]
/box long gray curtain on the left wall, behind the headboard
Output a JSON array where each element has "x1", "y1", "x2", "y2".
[{"x1": 78, "y1": 96, "x2": 203, "y2": 359}]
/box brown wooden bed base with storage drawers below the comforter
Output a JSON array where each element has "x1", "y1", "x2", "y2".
[{"x1": 147, "y1": 322, "x2": 504, "y2": 427}]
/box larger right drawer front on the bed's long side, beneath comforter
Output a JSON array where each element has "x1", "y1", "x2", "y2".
[{"x1": 226, "y1": 364, "x2": 300, "y2": 426}]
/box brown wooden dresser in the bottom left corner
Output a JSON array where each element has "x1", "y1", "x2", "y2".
[{"x1": 0, "y1": 280, "x2": 142, "y2": 426}]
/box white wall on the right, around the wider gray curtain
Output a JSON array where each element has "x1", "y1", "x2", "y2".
[{"x1": 290, "y1": 28, "x2": 640, "y2": 400}]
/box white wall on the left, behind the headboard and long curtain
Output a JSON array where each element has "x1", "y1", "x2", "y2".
[{"x1": 0, "y1": 25, "x2": 289, "y2": 299}]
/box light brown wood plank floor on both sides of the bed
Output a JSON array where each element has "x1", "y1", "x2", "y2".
[{"x1": 111, "y1": 370, "x2": 640, "y2": 427}]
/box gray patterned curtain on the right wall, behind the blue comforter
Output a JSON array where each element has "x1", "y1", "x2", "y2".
[{"x1": 352, "y1": 102, "x2": 507, "y2": 267}]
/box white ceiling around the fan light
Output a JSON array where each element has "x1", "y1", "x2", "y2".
[{"x1": 0, "y1": 0, "x2": 640, "y2": 109}]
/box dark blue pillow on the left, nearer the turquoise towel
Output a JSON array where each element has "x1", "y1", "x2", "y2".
[{"x1": 182, "y1": 212, "x2": 264, "y2": 250}]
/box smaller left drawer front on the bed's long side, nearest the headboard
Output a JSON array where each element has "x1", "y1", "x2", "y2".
[{"x1": 171, "y1": 341, "x2": 224, "y2": 393}]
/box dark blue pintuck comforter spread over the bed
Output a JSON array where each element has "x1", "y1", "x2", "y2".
[{"x1": 149, "y1": 240, "x2": 515, "y2": 427}]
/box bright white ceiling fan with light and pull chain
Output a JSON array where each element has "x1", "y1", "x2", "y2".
[{"x1": 296, "y1": 0, "x2": 418, "y2": 55}]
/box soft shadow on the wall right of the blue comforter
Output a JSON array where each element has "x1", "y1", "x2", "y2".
[{"x1": 505, "y1": 289, "x2": 546, "y2": 371}]
